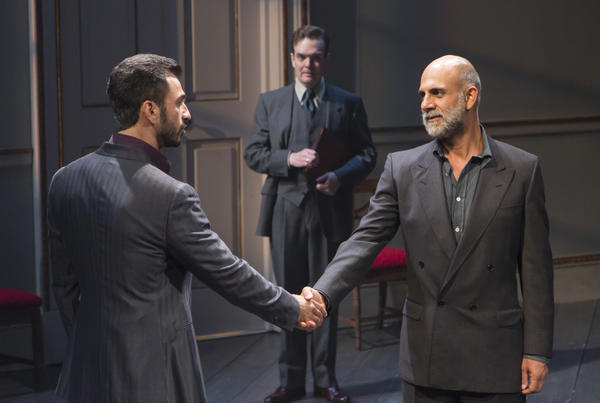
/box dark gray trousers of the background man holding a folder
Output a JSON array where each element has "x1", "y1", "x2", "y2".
[{"x1": 271, "y1": 195, "x2": 339, "y2": 390}]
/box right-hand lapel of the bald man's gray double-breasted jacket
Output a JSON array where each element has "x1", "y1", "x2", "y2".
[{"x1": 441, "y1": 137, "x2": 515, "y2": 294}]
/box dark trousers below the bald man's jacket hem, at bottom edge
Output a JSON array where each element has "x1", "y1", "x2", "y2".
[{"x1": 402, "y1": 382, "x2": 525, "y2": 403}]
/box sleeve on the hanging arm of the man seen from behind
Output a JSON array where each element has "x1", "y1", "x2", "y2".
[{"x1": 48, "y1": 173, "x2": 80, "y2": 335}]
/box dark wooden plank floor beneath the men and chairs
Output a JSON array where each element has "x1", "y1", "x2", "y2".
[{"x1": 0, "y1": 268, "x2": 600, "y2": 403}]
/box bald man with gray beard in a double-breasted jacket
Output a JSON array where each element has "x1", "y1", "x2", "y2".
[{"x1": 304, "y1": 55, "x2": 554, "y2": 403}]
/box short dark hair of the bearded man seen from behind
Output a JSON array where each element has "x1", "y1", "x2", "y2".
[{"x1": 106, "y1": 54, "x2": 181, "y2": 129}]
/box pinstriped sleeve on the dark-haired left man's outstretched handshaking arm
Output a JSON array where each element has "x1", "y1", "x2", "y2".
[{"x1": 166, "y1": 184, "x2": 299, "y2": 330}]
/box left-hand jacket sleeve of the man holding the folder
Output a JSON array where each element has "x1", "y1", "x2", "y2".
[{"x1": 244, "y1": 94, "x2": 290, "y2": 177}]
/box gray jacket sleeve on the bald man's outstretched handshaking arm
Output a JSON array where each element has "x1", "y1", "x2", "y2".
[{"x1": 313, "y1": 155, "x2": 400, "y2": 306}]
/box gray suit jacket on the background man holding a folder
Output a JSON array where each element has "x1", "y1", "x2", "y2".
[{"x1": 244, "y1": 84, "x2": 377, "y2": 241}]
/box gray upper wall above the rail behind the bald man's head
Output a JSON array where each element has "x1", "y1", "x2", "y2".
[{"x1": 357, "y1": 0, "x2": 600, "y2": 127}]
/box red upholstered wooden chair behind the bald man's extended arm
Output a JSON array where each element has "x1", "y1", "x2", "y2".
[{"x1": 339, "y1": 180, "x2": 406, "y2": 350}]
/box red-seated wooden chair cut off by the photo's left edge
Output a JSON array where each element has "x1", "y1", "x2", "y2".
[{"x1": 0, "y1": 288, "x2": 44, "y2": 391}]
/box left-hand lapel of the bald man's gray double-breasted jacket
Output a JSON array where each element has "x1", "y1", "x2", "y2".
[{"x1": 412, "y1": 142, "x2": 456, "y2": 259}]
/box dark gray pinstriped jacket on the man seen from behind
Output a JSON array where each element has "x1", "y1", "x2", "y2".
[{"x1": 48, "y1": 143, "x2": 298, "y2": 403}]
